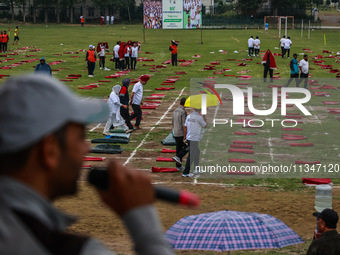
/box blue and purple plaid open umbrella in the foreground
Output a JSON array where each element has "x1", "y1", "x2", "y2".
[{"x1": 165, "y1": 211, "x2": 303, "y2": 251}]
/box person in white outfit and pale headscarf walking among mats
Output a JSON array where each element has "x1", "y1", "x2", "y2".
[{"x1": 103, "y1": 85, "x2": 129, "y2": 135}]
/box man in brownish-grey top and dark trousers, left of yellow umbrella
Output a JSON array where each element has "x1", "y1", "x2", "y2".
[{"x1": 172, "y1": 97, "x2": 188, "y2": 171}]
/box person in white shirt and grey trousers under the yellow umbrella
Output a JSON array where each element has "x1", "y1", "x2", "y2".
[{"x1": 182, "y1": 108, "x2": 207, "y2": 177}]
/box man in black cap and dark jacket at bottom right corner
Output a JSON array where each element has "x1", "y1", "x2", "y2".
[{"x1": 307, "y1": 209, "x2": 340, "y2": 255}]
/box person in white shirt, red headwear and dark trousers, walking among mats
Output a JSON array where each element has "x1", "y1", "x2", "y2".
[{"x1": 130, "y1": 75, "x2": 150, "y2": 129}]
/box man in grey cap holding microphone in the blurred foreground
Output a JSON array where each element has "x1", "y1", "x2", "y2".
[{"x1": 0, "y1": 75, "x2": 173, "y2": 255}]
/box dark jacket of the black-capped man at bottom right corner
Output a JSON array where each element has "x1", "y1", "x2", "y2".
[{"x1": 307, "y1": 230, "x2": 340, "y2": 255}]
